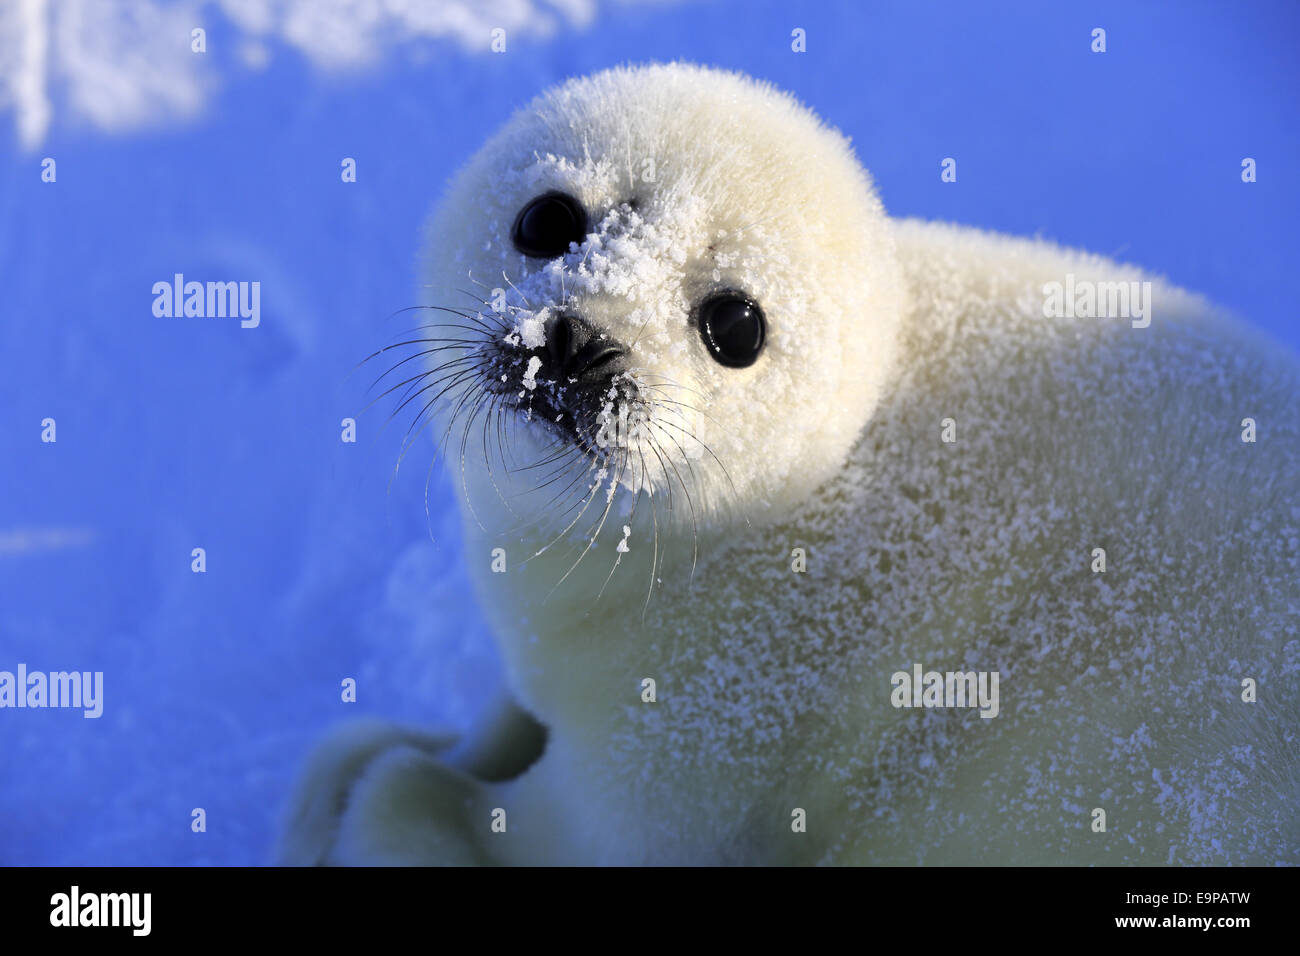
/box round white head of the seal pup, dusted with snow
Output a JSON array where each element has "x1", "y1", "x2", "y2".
[{"x1": 402, "y1": 65, "x2": 902, "y2": 535}]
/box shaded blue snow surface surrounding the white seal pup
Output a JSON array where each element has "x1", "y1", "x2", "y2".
[{"x1": 0, "y1": 0, "x2": 1300, "y2": 864}]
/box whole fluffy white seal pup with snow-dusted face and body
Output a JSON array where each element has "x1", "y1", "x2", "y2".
[{"x1": 281, "y1": 65, "x2": 1300, "y2": 865}]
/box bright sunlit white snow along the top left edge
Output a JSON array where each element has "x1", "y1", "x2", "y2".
[{"x1": 0, "y1": 0, "x2": 691, "y2": 150}]
